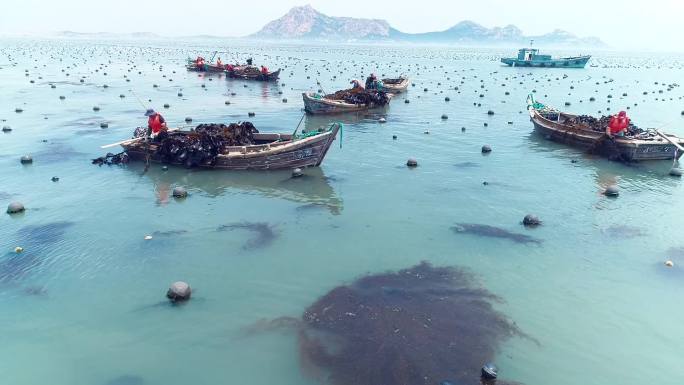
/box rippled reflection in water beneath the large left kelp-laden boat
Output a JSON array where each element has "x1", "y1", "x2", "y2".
[{"x1": 126, "y1": 163, "x2": 343, "y2": 215}]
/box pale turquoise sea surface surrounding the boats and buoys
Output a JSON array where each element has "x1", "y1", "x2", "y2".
[{"x1": 0, "y1": 40, "x2": 684, "y2": 385}]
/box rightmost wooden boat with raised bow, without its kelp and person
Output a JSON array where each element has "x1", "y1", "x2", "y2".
[{"x1": 527, "y1": 95, "x2": 684, "y2": 162}]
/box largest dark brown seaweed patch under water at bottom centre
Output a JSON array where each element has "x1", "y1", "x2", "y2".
[{"x1": 247, "y1": 262, "x2": 524, "y2": 385}]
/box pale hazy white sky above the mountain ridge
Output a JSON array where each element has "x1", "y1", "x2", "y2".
[{"x1": 0, "y1": 0, "x2": 684, "y2": 51}]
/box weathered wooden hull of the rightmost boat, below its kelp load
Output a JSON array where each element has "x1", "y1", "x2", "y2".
[{"x1": 530, "y1": 109, "x2": 684, "y2": 162}]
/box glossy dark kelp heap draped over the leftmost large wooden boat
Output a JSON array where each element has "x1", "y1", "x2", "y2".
[{"x1": 157, "y1": 122, "x2": 259, "y2": 167}]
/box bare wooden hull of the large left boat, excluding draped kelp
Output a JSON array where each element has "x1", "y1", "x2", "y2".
[{"x1": 120, "y1": 123, "x2": 342, "y2": 170}]
